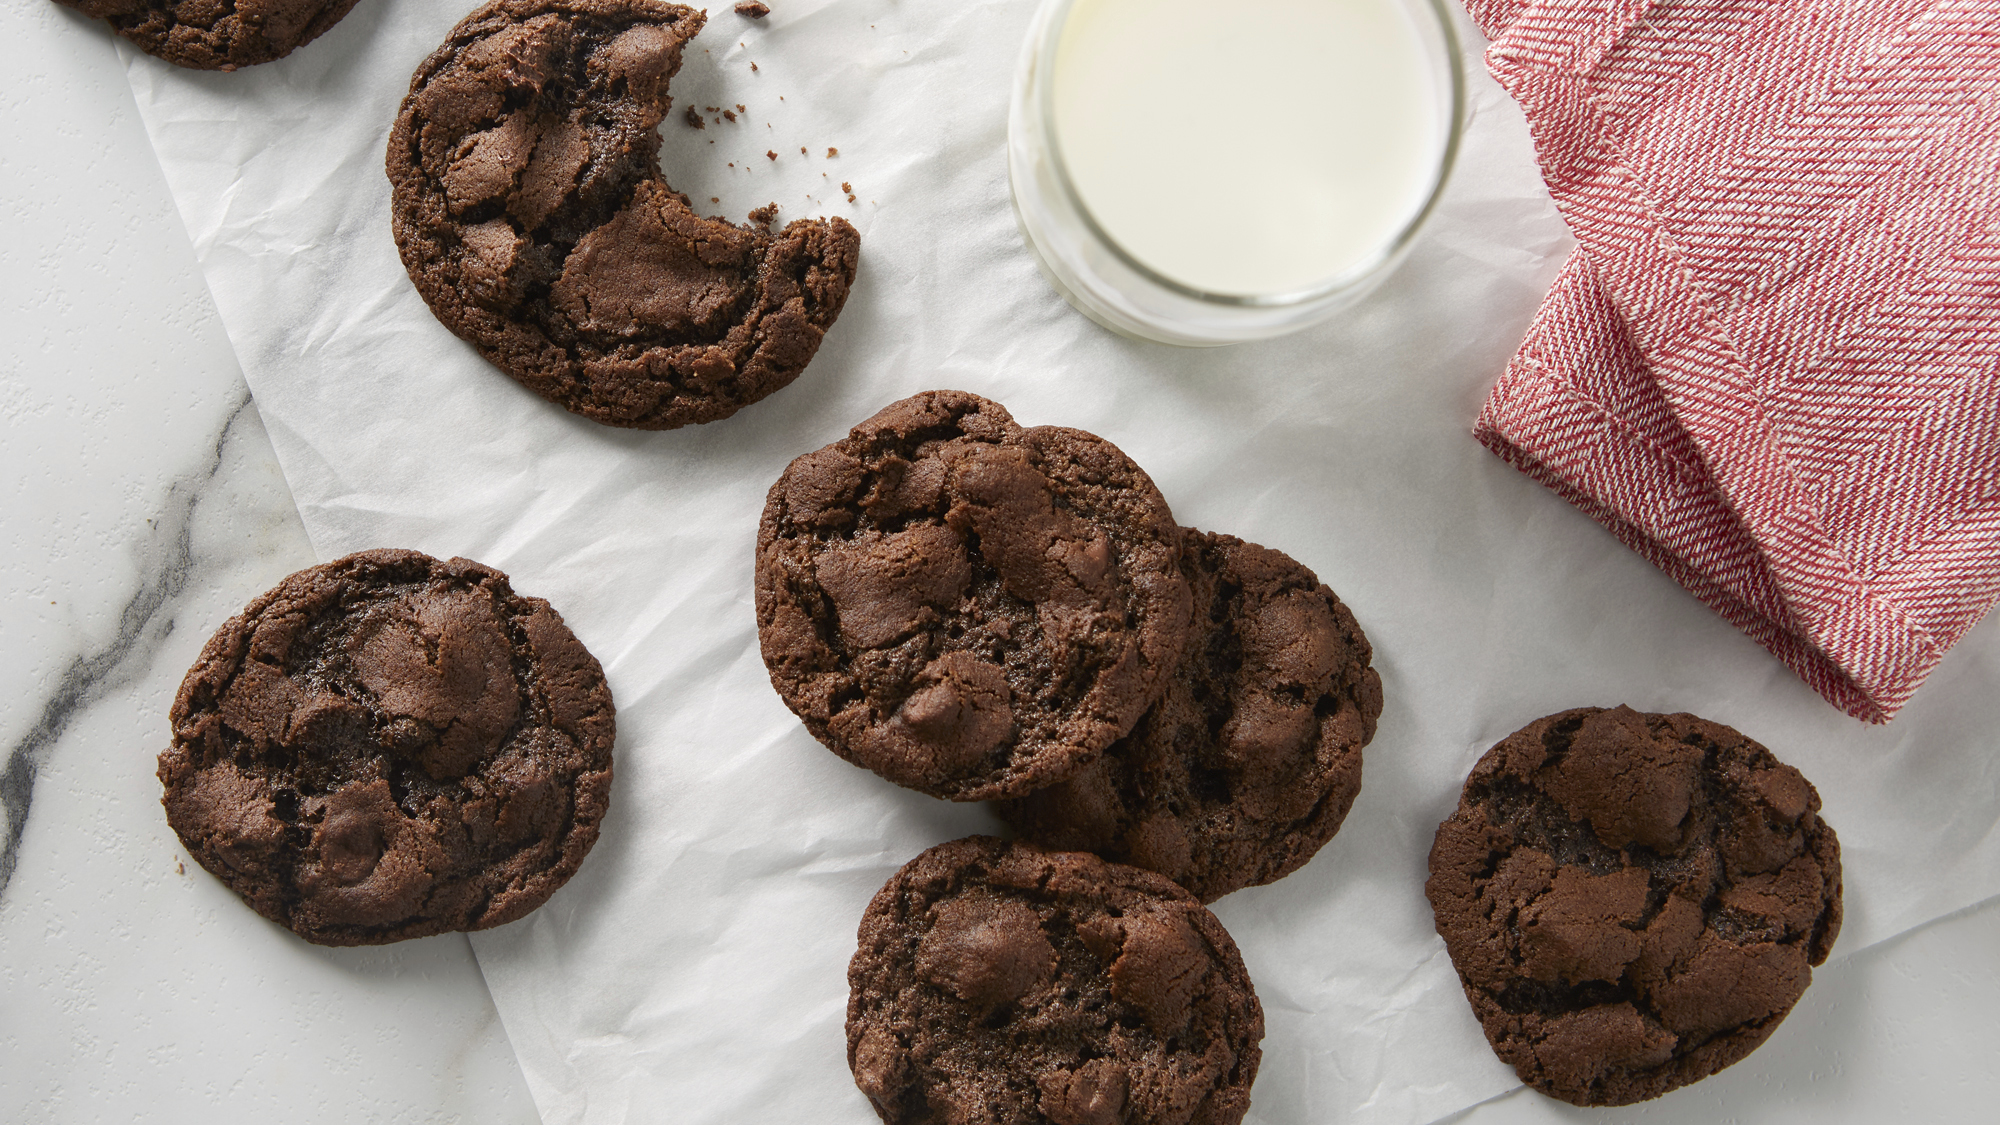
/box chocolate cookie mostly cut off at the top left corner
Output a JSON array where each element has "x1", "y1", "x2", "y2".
[{"x1": 58, "y1": 0, "x2": 354, "y2": 70}]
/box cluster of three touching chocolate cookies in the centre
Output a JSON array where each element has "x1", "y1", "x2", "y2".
[{"x1": 756, "y1": 390, "x2": 1382, "y2": 1123}]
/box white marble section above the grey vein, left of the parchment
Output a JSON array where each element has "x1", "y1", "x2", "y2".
[{"x1": 0, "y1": 0, "x2": 244, "y2": 764}]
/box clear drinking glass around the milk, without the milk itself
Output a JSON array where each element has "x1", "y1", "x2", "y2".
[{"x1": 1008, "y1": 0, "x2": 1464, "y2": 346}]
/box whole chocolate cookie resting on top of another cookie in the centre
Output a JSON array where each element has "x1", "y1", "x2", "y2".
[{"x1": 756, "y1": 390, "x2": 1188, "y2": 801}]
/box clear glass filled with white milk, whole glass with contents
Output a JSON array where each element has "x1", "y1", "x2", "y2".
[{"x1": 1008, "y1": 0, "x2": 1464, "y2": 346}]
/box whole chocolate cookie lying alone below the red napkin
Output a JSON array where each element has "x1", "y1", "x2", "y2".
[{"x1": 1424, "y1": 707, "x2": 1840, "y2": 1105}]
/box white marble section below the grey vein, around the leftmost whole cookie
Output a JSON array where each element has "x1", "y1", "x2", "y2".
[{"x1": 0, "y1": 378, "x2": 534, "y2": 1123}]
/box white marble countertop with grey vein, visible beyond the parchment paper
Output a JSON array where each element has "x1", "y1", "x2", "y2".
[{"x1": 0, "y1": 0, "x2": 2000, "y2": 1123}]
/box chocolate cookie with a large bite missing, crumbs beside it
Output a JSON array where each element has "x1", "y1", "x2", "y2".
[{"x1": 388, "y1": 0, "x2": 860, "y2": 430}]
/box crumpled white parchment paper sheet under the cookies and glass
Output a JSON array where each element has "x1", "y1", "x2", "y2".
[{"x1": 117, "y1": 0, "x2": 2000, "y2": 1125}]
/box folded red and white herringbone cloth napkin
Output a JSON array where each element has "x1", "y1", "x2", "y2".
[{"x1": 1466, "y1": 0, "x2": 2000, "y2": 723}]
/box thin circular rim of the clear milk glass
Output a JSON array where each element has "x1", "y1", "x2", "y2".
[{"x1": 1028, "y1": 0, "x2": 1466, "y2": 308}]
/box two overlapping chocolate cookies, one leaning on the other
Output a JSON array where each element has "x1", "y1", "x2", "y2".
[{"x1": 756, "y1": 390, "x2": 1382, "y2": 901}]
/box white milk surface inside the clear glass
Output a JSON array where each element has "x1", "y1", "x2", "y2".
[{"x1": 1052, "y1": 0, "x2": 1448, "y2": 296}]
